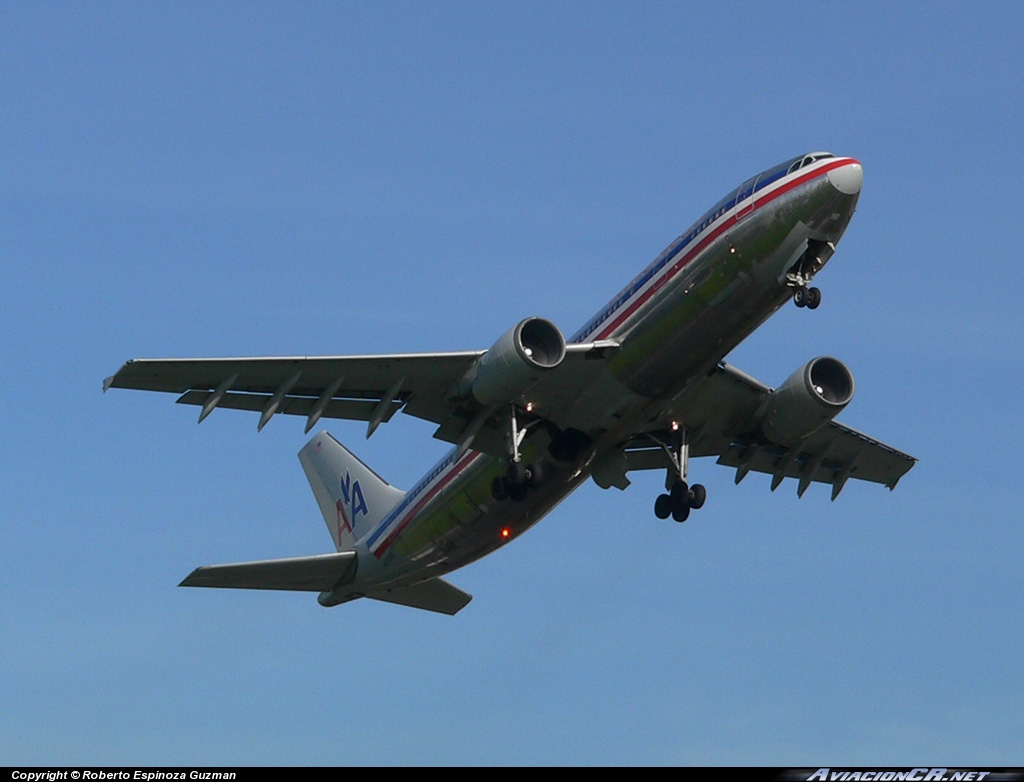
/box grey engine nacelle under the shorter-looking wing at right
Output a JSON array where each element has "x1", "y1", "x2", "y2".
[{"x1": 761, "y1": 356, "x2": 853, "y2": 444}]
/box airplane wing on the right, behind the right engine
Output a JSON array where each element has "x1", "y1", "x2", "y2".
[{"x1": 624, "y1": 363, "x2": 916, "y2": 499}]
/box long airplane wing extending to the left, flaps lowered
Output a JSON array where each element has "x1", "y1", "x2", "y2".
[{"x1": 103, "y1": 340, "x2": 617, "y2": 442}]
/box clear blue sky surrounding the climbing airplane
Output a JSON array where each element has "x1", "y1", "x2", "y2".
[{"x1": 0, "y1": 2, "x2": 1024, "y2": 766}]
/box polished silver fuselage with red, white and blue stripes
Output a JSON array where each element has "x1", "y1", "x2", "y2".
[{"x1": 350, "y1": 156, "x2": 861, "y2": 595}]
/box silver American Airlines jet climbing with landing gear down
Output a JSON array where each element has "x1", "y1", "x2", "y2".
[{"x1": 103, "y1": 151, "x2": 916, "y2": 614}]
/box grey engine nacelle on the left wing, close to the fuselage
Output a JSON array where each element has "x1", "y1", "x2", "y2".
[{"x1": 471, "y1": 317, "x2": 565, "y2": 405}]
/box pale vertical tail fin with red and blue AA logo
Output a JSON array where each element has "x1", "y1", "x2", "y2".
[{"x1": 299, "y1": 432, "x2": 406, "y2": 551}]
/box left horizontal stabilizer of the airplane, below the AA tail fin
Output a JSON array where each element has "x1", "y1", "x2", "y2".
[{"x1": 178, "y1": 551, "x2": 358, "y2": 593}]
